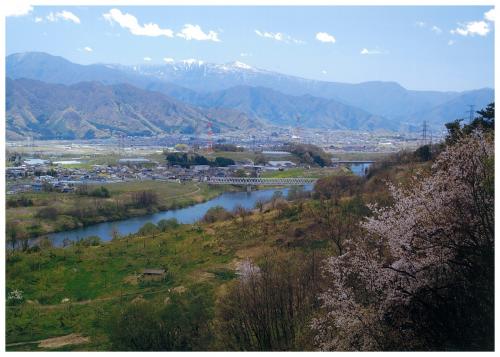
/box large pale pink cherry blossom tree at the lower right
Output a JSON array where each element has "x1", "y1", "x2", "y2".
[{"x1": 313, "y1": 132, "x2": 494, "y2": 350}]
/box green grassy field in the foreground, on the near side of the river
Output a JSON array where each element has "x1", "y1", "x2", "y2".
[{"x1": 6, "y1": 202, "x2": 334, "y2": 350}]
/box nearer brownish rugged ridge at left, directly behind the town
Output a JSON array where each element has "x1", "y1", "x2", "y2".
[{"x1": 6, "y1": 78, "x2": 263, "y2": 139}]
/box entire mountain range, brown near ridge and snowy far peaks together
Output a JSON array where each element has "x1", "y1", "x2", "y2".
[{"x1": 6, "y1": 52, "x2": 494, "y2": 138}]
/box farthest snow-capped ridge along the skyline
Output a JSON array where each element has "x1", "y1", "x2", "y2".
[{"x1": 111, "y1": 58, "x2": 493, "y2": 119}]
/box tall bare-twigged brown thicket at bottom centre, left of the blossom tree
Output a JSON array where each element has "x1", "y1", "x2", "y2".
[{"x1": 216, "y1": 255, "x2": 321, "y2": 351}]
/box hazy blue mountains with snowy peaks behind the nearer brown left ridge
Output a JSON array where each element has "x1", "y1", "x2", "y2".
[{"x1": 6, "y1": 52, "x2": 494, "y2": 138}]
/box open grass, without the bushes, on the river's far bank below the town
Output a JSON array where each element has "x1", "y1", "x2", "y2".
[{"x1": 6, "y1": 181, "x2": 234, "y2": 236}]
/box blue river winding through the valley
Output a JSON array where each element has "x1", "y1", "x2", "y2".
[{"x1": 48, "y1": 185, "x2": 312, "y2": 246}]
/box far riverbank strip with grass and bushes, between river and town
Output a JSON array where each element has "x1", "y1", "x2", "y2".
[{"x1": 6, "y1": 181, "x2": 236, "y2": 241}]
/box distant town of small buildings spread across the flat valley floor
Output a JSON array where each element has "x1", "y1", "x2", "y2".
[{"x1": 6, "y1": 128, "x2": 419, "y2": 194}]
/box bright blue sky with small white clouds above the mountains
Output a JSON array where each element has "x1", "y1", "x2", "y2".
[{"x1": 6, "y1": 6, "x2": 495, "y2": 91}]
